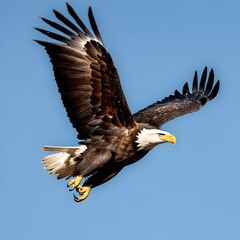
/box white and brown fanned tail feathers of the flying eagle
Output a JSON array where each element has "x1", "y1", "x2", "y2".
[{"x1": 42, "y1": 145, "x2": 87, "y2": 179}]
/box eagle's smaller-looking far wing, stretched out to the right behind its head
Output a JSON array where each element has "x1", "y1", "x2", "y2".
[{"x1": 133, "y1": 67, "x2": 220, "y2": 128}]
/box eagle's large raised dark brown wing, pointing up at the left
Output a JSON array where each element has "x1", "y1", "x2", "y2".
[{"x1": 36, "y1": 4, "x2": 135, "y2": 139}]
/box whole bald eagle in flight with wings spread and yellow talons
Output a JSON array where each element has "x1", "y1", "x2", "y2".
[{"x1": 36, "y1": 3, "x2": 220, "y2": 202}]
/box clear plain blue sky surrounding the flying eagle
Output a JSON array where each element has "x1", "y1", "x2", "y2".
[{"x1": 0, "y1": 0, "x2": 240, "y2": 240}]
